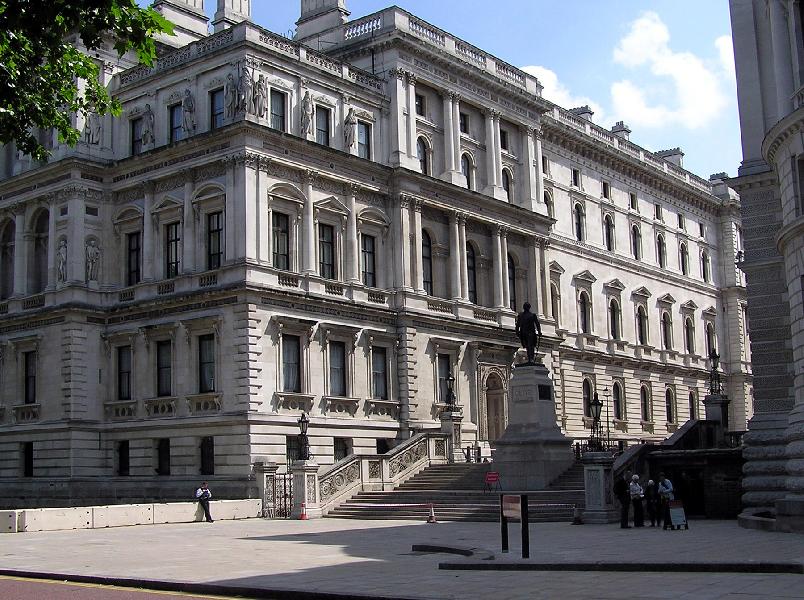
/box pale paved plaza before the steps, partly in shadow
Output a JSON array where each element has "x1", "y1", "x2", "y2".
[{"x1": 0, "y1": 519, "x2": 804, "y2": 600}]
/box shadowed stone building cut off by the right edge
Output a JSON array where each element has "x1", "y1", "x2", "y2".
[{"x1": 729, "y1": 0, "x2": 804, "y2": 531}]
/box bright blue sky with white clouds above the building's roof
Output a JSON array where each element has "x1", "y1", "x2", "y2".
[{"x1": 148, "y1": 0, "x2": 741, "y2": 177}]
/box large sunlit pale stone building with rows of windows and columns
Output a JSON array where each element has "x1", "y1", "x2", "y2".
[{"x1": 0, "y1": 0, "x2": 752, "y2": 502}]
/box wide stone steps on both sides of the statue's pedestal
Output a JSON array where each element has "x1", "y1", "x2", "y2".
[{"x1": 327, "y1": 463, "x2": 584, "y2": 523}]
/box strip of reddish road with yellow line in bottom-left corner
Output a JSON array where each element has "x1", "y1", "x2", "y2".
[{"x1": 0, "y1": 576, "x2": 242, "y2": 600}]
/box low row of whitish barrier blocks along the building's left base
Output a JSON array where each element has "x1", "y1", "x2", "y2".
[{"x1": 0, "y1": 499, "x2": 262, "y2": 533}]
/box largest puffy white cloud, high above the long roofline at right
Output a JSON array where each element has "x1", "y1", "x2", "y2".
[{"x1": 611, "y1": 12, "x2": 727, "y2": 129}]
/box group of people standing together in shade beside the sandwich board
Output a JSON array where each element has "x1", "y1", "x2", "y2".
[{"x1": 613, "y1": 471, "x2": 674, "y2": 529}]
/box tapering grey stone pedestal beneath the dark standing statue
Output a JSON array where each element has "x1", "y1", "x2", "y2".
[{"x1": 494, "y1": 358, "x2": 575, "y2": 491}]
